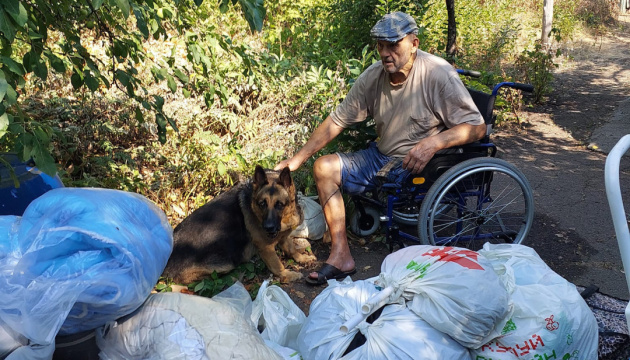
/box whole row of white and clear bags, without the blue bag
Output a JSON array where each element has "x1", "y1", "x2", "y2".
[{"x1": 98, "y1": 244, "x2": 598, "y2": 360}]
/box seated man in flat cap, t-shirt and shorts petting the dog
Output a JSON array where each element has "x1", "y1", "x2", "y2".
[{"x1": 275, "y1": 12, "x2": 486, "y2": 285}]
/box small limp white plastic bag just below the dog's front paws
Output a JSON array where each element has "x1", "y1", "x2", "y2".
[{"x1": 252, "y1": 280, "x2": 306, "y2": 349}]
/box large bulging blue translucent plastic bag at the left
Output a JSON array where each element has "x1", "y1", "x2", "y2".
[{"x1": 0, "y1": 188, "x2": 173, "y2": 345}]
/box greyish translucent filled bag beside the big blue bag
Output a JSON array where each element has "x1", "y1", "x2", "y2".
[{"x1": 96, "y1": 283, "x2": 282, "y2": 360}]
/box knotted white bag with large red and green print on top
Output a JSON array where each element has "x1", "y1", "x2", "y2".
[{"x1": 375, "y1": 245, "x2": 510, "y2": 348}]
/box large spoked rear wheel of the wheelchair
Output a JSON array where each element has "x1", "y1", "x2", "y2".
[{"x1": 418, "y1": 158, "x2": 534, "y2": 250}]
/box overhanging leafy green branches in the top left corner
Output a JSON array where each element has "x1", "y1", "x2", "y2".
[{"x1": 0, "y1": 0, "x2": 265, "y2": 174}]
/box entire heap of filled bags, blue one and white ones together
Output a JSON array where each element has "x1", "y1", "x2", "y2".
[{"x1": 0, "y1": 188, "x2": 598, "y2": 360}]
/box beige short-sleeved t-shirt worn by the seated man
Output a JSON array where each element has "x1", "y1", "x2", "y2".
[{"x1": 330, "y1": 50, "x2": 484, "y2": 157}]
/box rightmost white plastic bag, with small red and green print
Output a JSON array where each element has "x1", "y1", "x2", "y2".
[{"x1": 471, "y1": 243, "x2": 598, "y2": 360}]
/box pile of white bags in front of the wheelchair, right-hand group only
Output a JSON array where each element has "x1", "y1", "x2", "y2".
[{"x1": 298, "y1": 244, "x2": 598, "y2": 360}]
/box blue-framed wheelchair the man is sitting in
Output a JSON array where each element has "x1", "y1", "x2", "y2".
[{"x1": 349, "y1": 69, "x2": 534, "y2": 251}]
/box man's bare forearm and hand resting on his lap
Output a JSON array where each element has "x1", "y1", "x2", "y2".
[{"x1": 403, "y1": 123, "x2": 486, "y2": 174}]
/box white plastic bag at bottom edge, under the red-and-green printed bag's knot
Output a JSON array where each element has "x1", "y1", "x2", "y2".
[{"x1": 341, "y1": 304, "x2": 470, "y2": 360}]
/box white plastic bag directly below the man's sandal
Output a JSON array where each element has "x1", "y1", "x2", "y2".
[{"x1": 297, "y1": 278, "x2": 378, "y2": 360}]
